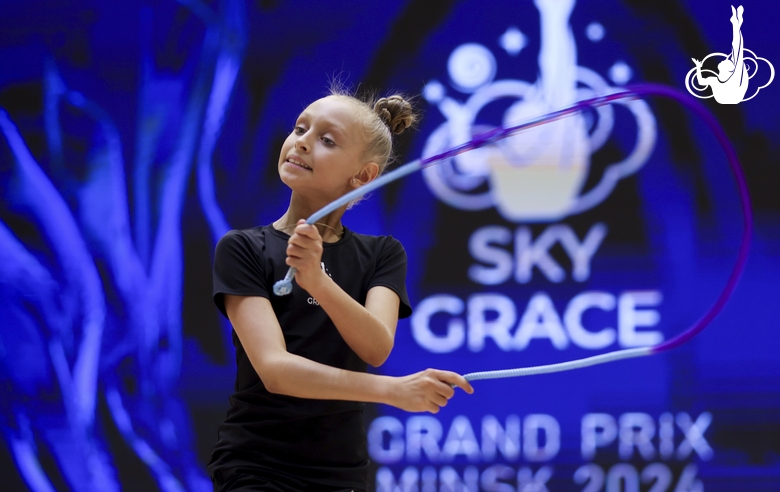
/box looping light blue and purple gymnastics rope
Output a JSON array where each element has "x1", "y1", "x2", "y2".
[{"x1": 273, "y1": 84, "x2": 753, "y2": 381}]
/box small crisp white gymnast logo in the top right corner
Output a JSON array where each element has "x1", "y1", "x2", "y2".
[{"x1": 685, "y1": 5, "x2": 775, "y2": 104}]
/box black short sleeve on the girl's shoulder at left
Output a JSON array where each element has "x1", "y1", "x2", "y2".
[{"x1": 213, "y1": 230, "x2": 269, "y2": 317}]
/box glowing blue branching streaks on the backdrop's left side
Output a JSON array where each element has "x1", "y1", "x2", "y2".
[{"x1": 0, "y1": 0, "x2": 246, "y2": 491}]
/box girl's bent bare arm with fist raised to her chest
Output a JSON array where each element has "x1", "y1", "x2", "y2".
[{"x1": 286, "y1": 223, "x2": 401, "y2": 367}]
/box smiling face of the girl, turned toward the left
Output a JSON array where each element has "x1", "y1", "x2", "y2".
[{"x1": 279, "y1": 96, "x2": 376, "y2": 201}]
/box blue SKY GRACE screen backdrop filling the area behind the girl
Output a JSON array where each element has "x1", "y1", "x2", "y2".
[{"x1": 0, "y1": 0, "x2": 780, "y2": 492}]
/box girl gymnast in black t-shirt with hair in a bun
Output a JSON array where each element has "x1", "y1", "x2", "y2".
[{"x1": 209, "y1": 89, "x2": 473, "y2": 492}]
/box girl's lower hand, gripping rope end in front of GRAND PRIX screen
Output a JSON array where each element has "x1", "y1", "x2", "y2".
[{"x1": 390, "y1": 369, "x2": 474, "y2": 413}]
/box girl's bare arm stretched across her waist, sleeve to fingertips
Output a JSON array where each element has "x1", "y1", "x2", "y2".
[{"x1": 225, "y1": 295, "x2": 474, "y2": 413}]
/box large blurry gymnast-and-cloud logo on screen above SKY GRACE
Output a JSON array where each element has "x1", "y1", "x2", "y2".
[{"x1": 423, "y1": 0, "x2": 656, "y2": 222}]
